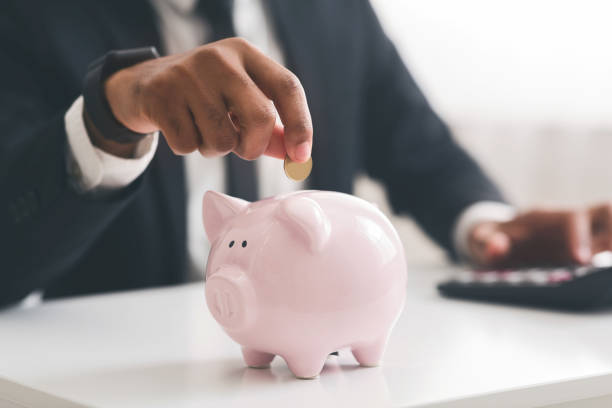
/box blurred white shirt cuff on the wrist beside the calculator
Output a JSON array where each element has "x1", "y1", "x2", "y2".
[{"x1": 453, "y1": 201, "x2": 516, "y2": 261}]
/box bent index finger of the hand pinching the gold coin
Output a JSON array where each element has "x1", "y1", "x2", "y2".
[{"x1": 243, "y1": 42, "x2": 312, "y2": 162}]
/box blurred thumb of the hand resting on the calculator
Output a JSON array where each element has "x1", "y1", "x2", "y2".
[{"x1": 470, "y1": 223, "x2": 512, "y2": 266}]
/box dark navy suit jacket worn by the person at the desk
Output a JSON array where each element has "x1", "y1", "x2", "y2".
[{"x1": 0, "y1": 0, "x2": 501, "y2": 305}]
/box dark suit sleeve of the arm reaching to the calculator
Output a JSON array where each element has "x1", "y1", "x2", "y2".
[{"x1": 362, "y1": 1, "x2": 503, "y2": 254}]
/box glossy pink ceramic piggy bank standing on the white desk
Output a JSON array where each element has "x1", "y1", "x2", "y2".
[{"x1": 203, "y1": 191, "x2": 406, "y2": 378}]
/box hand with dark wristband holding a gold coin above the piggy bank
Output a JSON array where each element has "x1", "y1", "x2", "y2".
[{"x1": 105, "y1": 38, "x2": 312, "y2": 162}]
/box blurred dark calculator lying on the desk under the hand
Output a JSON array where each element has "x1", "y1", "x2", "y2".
[{"x1": 438, "y1": 251, "x2": 612, "y2": 310}]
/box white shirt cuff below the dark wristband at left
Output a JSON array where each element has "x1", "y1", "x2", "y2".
[{"x1": 64, "y1": 96, "x2": 159, "y2": 192}]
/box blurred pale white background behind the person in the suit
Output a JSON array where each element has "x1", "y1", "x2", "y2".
[{"x1": 356, "y1": 0, "x2": 612, "y2": 265}]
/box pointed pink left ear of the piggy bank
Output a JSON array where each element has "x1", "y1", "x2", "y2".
[{"x1": 202, "y1": 190, "x2": 249, "y2": 242}]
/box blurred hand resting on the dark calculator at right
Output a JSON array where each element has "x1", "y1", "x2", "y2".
[{"x1": 469, "y1": 203, "x2": 612, "y2": 268}]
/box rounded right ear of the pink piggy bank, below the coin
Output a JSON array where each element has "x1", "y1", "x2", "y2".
[{"x1": 279, "y1": 196, "x2": 331, "y2": 253}]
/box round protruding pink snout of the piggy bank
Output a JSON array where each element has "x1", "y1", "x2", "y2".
[{"x1": 206, "y1": 267, "x2": 256, "y2": 331}]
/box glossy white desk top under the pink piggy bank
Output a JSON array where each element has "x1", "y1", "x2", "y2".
[{"x1": 0, "y1": 271, "x2": 612, "y2": 408}]
